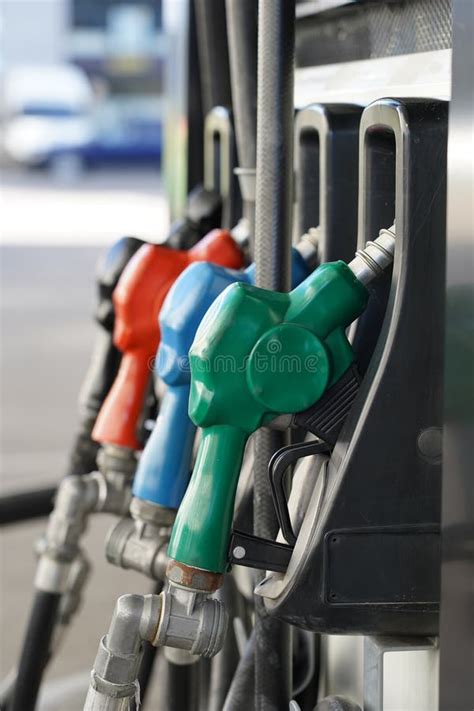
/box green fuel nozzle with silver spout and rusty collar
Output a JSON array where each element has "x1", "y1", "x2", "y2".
[{"x1": 168, "y1": 226, "x2": 395, "y2": 587}]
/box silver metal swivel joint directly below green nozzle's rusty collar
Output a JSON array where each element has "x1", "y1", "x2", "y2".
[{"x1": 152, "y1": 583, "x2": 228, "y2": 663}]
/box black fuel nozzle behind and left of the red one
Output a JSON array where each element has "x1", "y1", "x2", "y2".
[{"x1": 67, "y1": 237, "x2": 144, "y2": 475}]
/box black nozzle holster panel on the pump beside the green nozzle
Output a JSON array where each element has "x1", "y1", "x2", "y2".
[{"x1": 260, "y1": 99, "x2": 448, "y2": 635}]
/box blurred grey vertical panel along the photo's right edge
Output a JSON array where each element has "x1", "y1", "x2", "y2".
[{"x1": 439, "y1": 0, "x2": 474, "y2": 711}]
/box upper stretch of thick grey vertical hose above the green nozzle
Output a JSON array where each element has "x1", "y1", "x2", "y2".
[{"x1": 255, "y1": 0, "x2": 295, "y2": 291}]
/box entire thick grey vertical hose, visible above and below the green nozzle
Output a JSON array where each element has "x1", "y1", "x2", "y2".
[{"x1": 254, "y1": 0, "x2": 295, "y2": 711}]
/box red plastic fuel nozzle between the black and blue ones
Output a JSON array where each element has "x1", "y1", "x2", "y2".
[{"x1": 92, "y1": 230, "x2": 243, "y2": 449}]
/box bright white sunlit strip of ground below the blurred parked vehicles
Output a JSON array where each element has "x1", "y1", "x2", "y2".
[{"x1": 0, "y1": 165, "x2": 168, "y2": 246}]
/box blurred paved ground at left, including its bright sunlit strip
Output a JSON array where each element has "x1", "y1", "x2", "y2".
[{"x1": 0, "y1": 167, "x2": 166, "y2": 711}]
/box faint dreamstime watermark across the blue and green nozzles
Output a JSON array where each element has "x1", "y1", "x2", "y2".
[{"x1": 148, "y1": 338, "x2": 321, "y2": 375}]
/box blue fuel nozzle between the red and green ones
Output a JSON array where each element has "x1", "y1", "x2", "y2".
[{"x1": 133, "y1": 248, "x2": 310, "y2": 509}]
